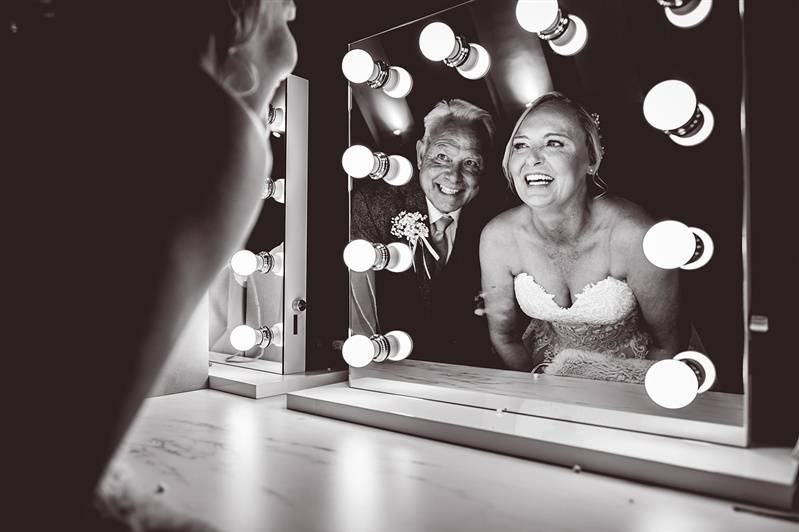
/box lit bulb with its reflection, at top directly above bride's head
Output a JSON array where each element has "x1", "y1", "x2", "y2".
[{"x1": 516, "y1": 0, "x2": 588, "y2": 56}]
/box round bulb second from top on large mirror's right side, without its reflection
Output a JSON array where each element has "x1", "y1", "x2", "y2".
[{"x1": 644, "y1": 79, "x2": 697, "y2": 131}]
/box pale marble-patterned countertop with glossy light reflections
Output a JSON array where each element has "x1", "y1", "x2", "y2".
[{"x1": 117, "y1": 390, "x2": 797, "y2": 532}]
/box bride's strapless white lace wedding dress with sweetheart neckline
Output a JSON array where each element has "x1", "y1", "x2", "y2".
[{"x1": 513, "y1": 273, "x2": 652, "y2": 362}]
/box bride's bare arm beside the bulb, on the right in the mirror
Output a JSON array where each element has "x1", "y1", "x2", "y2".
[{"x1": 614, "y1": 211, "x2": 687, "y2": 360}]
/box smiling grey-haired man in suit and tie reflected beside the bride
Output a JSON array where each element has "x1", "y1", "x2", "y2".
[{"x1": 351, "y1": 99, "x2": 501, "y2": 367}]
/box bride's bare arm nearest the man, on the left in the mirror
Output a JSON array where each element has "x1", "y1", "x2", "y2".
[{"x1": 480, "y1": 215, "x2": 533, "y2": 371}]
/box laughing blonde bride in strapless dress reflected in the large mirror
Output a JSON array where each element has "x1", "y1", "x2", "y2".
[{"x1": 480, "y1": 92, "x2": 685, "y2": 371}]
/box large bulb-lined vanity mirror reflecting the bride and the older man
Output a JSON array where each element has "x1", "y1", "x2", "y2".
[{"x1": 342, "y1": 0, "x2": 749, "y2": 446}]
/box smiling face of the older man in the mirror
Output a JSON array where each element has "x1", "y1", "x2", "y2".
[{"x1": 416, "y1": 119, "x2": 487, "y2": 213}]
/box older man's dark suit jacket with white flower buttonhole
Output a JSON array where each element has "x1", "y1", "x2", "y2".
[{"x1": 350, "y1": 179, "x2": 504, "y2": 367}]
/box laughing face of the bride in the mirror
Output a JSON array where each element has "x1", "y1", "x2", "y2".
[{"x1": 508, "y1": 102, "x2": 590, "y2": 211}]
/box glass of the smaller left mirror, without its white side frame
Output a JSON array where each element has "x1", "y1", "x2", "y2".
[{"x1": 210, "y1": 81, "x2": 287, "y2": 373}]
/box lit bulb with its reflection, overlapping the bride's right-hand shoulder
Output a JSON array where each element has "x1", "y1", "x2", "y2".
[{"x1": 643, "y1": 220, "x2": 714, "y2": 270}]
